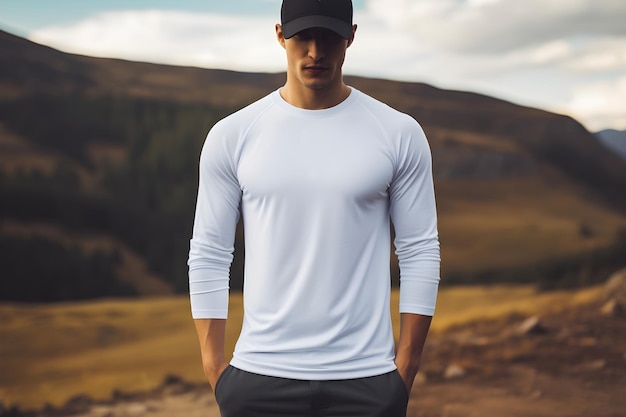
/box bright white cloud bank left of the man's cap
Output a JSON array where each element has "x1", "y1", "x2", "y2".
[{"x1": 29, "y1": 10, "x2": 284, "y2": 71}]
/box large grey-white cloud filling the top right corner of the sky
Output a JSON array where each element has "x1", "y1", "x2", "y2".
[{"x1": 367, "y1": 0, "x2": 626, "y2": 54}]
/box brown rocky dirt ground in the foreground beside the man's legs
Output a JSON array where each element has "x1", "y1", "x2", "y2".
[{"x1": 0, "y1": 290, "x2": 626, "y2": 417}]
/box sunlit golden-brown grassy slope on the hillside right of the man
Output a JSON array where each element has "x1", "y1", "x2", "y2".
[{"x1": 437, "y1": 178, "x2": 626, "y2": 273}]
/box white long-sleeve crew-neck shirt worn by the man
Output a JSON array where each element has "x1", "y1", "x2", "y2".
[{"x1": 189, "y1": 89, "x2": 440, "y2": 380}]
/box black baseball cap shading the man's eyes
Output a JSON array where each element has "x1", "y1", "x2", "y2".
[{"x1": 280, "y1": 0, "x2": 352, "y2": 39}]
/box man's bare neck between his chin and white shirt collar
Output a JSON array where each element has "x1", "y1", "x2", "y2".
[{"x1": 280, "y1": 79, "x2": 351, "y2": 110}]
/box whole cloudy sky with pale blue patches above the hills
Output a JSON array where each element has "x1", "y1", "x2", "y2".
[{"x1": 0, "y1": 0, "x2": 626, "y2": 131}]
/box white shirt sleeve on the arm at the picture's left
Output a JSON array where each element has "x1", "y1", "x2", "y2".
[{"x1": 188, "y1": 123, "x2": 241, "y2": 319}]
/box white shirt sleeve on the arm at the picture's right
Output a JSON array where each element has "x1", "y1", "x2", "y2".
[{"x1": 390, "y1": 119, "x2": 441, "y2": 316}]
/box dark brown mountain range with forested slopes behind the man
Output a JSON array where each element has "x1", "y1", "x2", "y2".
[{"x1": 0, "y1": 32, "x2": 626, "y2": 301}]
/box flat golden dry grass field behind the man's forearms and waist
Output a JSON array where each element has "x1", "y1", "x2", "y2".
[{"x1": 0, "y1": 286, "x2": 602, "y2": 409}]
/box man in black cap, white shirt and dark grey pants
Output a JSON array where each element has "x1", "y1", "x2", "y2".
[{"x1": 189, "y1": 0, "x2": 439, "y2": 417}]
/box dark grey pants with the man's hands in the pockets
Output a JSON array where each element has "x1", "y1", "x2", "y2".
[{"x1": 215, "y1": 366, "x2": 409, "y2": 417}]
